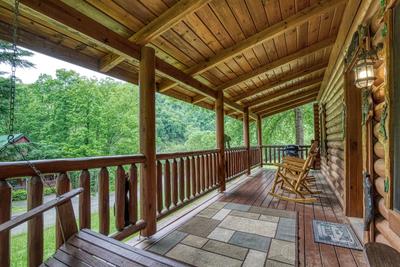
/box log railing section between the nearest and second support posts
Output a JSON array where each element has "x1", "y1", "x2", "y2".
[{"x1": 157, "y1": 149, "x2": 218, "y2": 219}]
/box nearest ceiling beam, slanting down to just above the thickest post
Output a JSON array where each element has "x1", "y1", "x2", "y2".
[{"x1": 100, "y1": 0, "x2": 211, "y2": 72}]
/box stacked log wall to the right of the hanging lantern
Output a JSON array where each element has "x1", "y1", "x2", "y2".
[{"x1": 371, "y1": 2, "x2": 400, "y2": 252}]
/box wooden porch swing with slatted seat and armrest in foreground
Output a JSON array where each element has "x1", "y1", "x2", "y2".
[{"x1": 0, "y1": 188, "x2": 187, "y2": 267}]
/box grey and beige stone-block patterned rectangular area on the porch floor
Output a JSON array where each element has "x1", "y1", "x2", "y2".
[{"x1": 148, "y1": 202, "x2": 297, "y2": 267}]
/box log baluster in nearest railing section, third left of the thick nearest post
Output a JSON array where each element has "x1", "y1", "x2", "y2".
[{"x1": 99, "y1": 167, "x2": 110, "y2": 235}]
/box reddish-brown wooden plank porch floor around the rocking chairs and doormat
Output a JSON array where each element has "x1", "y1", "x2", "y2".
[{"x1": 220, "y1": 170, "x2": 367, "y2": 267}]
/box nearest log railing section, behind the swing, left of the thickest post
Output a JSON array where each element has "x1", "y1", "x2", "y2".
[{"x1": 0, "y1": 155, "x2": 146, "y2": 266}]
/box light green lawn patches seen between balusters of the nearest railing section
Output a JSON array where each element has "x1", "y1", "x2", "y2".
[{"x1": 11, "y1": 209, "x2": 116, "y2": 266}]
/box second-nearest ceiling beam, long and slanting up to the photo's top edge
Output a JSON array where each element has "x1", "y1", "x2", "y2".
[{"x1": 160, "y1": 0, "x2": 344, "y2": 91}]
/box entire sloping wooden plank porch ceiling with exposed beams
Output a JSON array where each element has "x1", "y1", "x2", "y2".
[{"x1": 0, "y1": 0, "x2": 348, "y2": 118}]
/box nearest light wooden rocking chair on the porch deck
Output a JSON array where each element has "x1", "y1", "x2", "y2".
[{"x1": 269, "y1": 146, "x2": 321, "y2": 203}]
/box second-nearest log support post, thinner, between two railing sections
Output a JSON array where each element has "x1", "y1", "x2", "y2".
[{"x1": 215, "y1": 91, "x2": 225, "y2": 192}]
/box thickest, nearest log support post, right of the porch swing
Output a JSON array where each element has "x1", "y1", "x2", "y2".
[{"x1": 139, "y1": 46, "x2": 157, "y2": 237}]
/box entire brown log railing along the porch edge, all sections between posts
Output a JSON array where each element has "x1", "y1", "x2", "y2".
[{"x1": 0, "y1": 147, "x2": 261, "y2": 266}]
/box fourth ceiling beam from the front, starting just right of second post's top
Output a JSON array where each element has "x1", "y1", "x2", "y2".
[{"x1": 231, "y1": 63, "x2": 327, "y2": 102}]
